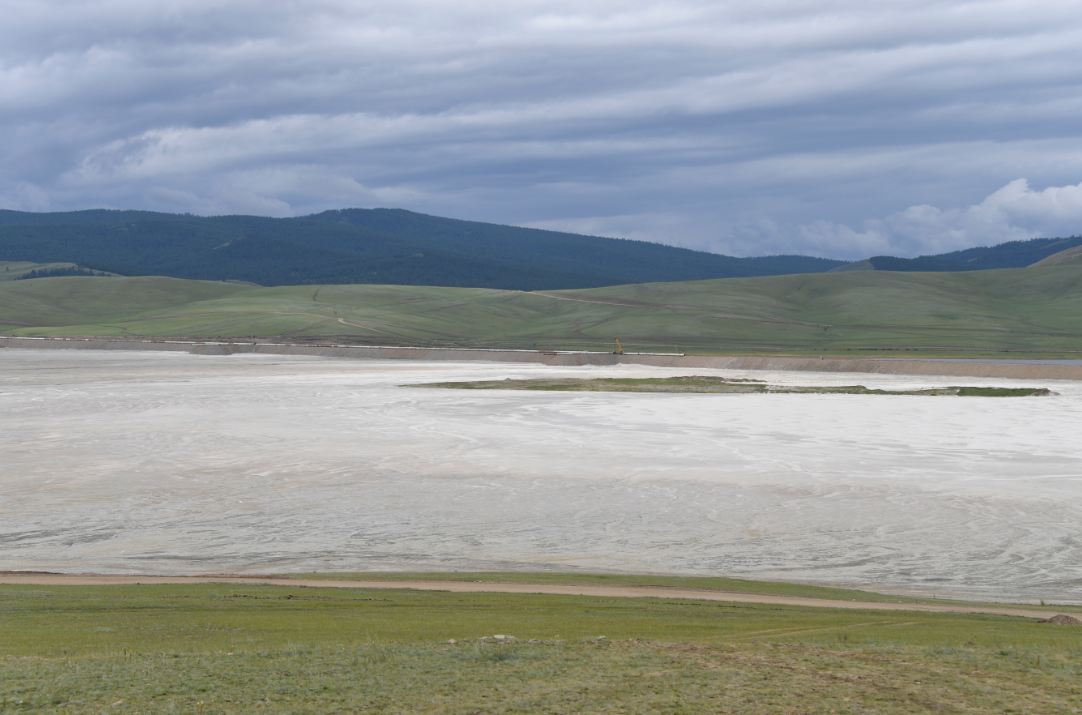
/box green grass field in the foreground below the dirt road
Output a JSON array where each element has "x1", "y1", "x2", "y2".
[{"x1": 0, "y1": 584, "x2": 1082, "y2": 713}]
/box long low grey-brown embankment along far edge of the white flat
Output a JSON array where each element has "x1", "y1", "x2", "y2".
[{"x1": 0, "y1": 336, "x2": 1082, "y2": 380}]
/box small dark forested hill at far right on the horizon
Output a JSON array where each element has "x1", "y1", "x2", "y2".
[{"x1": 856, "y1": 236, "x2": 1082, "y2": 272}]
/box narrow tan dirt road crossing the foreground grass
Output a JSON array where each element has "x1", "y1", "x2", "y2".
[{"x1": 0, "y1": 573, "x2": 1069, "y2": 619}]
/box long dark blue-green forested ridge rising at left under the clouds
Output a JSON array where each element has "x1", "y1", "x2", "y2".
[{"x1": 0, "y1": 209, "x2": 843, "y2": 290}]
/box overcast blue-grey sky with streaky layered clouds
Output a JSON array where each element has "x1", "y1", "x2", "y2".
[{"x1": 0, "y1": 0, "x2": 1082, "y2": 259}]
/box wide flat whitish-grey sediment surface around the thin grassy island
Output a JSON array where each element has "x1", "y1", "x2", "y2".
[{"x1": 0, "y1": 349, "x2": 1082, "y2": 601}]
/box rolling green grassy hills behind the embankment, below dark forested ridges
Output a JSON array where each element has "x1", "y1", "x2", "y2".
[{"x1": 0, "y1": 265, "x2": 1082, "y2": 354}]
